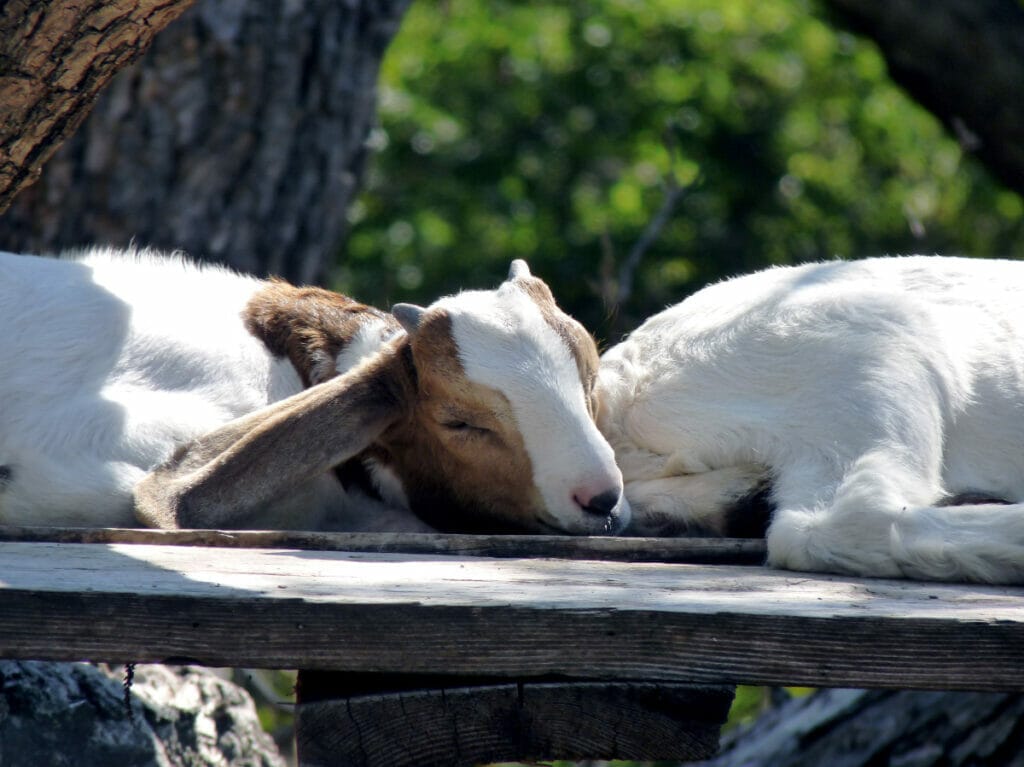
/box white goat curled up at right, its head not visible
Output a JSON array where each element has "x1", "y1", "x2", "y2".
[{"x1": 598, "y1": 256, "x2": 1024, "y2": 583}]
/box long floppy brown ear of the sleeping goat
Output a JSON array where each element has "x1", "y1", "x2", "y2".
[{"x1": 133, "y1": 344, "x2": 409, "y2": 528}]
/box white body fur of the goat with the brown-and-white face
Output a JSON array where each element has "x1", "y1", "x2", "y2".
[{"x1": 0, "y1": 249, "x2": 413, "y2": 527}]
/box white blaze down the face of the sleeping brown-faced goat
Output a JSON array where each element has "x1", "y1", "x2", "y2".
[{"x1": 436, "y1": 283, "x2": 622, "y2": 529}]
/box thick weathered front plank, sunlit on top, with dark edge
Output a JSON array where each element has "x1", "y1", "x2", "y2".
[{"x1": 0, "y1": 543, "x2": 1024, "y2": 690}]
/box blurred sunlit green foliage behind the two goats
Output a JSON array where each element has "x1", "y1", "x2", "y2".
[{"x1": 337, "y1": 0, "x2": 1024, "y2": 333}]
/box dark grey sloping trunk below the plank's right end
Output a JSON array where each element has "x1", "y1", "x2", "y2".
[{"x1": 699, "y1": 689, "x2": 1024, "y2": 767}]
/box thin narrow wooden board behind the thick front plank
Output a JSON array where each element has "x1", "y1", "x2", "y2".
[{"x1": 0, "y1": 525, "x2": 765, "y2": 564}]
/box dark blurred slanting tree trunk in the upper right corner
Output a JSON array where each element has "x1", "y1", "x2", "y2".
[{"x1": 825, "y1": 0, "x2": 1024, "y2": 194}]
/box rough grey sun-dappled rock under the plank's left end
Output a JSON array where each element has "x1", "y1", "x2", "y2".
[{"x1": 0, "y1": 661, "x2": 285, "y2": 767}]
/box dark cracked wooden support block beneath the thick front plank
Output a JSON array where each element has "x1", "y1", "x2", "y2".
[{"x1": 296, "y1": 682, "x2": 732, "y2": 767}]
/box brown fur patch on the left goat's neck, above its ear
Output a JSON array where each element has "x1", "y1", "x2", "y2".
[{"x1": 243, "y1": 279, "x2": 398, "y2": 387}]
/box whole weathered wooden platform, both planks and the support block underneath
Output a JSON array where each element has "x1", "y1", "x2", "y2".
[{"x1": 0, "y1": 528, "x2": 1024, "y2": 767}]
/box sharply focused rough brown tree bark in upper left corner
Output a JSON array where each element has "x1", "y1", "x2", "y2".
[{"x1": 0, "y1": 0, "x2": 195, "y2": 212}]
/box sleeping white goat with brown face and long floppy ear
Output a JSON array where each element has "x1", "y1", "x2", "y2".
[{"x1": 0, "y1": 251, "x2": 628, "y2": 534}]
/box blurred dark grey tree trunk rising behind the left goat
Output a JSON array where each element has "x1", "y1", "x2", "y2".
[{"x1": 0, "y1": 0, "x2": 409, "y2": 283}]
